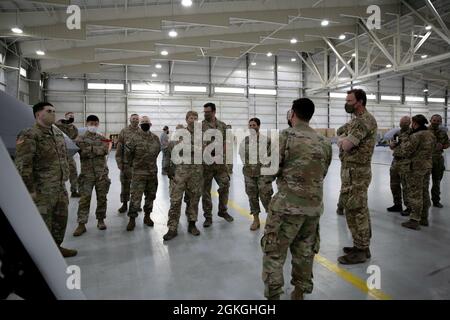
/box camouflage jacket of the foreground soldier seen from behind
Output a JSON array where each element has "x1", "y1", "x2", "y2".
[{"x1": 271, "y1": 123, "x2": 332, "y2": 216}]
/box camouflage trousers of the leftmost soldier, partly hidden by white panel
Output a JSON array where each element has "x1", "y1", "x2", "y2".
[{"x1": 34, "y1": 185, "x2": 69, "y2": 246}]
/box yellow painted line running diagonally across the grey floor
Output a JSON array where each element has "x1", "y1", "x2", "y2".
[{"x1": 211, "y1": 191, "x2": 392, "y2": 300}]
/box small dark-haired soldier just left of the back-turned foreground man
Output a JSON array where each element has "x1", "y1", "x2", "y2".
[{"x1": 239, "y1": 118, "x2": 273, "y2": 231}]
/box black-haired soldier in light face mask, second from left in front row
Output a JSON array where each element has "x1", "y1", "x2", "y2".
[{"x1": 73, "y1": 115, "x2": 111, "y2": 237}]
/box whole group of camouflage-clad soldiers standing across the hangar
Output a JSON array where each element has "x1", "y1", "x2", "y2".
[{"x1": 15, "y1": 89, "x2": 449, "y2": 299}]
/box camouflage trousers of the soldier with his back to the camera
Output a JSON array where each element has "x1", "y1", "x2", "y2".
[{"x1": 261, "y1": 211, "x2": 320, "y2": 298}]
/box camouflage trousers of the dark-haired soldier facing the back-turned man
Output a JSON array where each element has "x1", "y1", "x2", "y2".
[{"x1": 244, "y1": 175, "x2": 273, "y2": 214}]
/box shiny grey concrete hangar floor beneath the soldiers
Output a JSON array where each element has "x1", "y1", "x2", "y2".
[{"x1": 64, "y1": 147, "x2": 450, "y2": 299}]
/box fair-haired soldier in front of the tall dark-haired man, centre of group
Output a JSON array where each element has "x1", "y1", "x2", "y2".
[{"x1": 163, "y1": 111, "x2": 203, "y2": 241}]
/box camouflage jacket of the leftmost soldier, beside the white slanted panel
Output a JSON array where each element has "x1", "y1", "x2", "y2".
[{"x1": 15, "y1": 124, "x2": 69, "y2": 194}]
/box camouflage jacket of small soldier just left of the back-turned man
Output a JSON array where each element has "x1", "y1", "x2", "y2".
[{"x1": 239, "y1": 134, "x2": 270, "y2": 177}]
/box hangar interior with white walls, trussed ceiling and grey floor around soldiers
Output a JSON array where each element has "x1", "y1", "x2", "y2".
[{"x1": 0, "y1": 0, "x2": 450, "y2": 299}]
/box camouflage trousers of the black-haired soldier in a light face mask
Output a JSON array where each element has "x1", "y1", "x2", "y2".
[{"x1": 77, "y1": 174, "x2": 111, "y2": 223}]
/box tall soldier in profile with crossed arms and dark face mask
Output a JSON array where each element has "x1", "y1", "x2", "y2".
[{"x1": 338, "y1": 89, "x2": 377, "y2": 264}]
